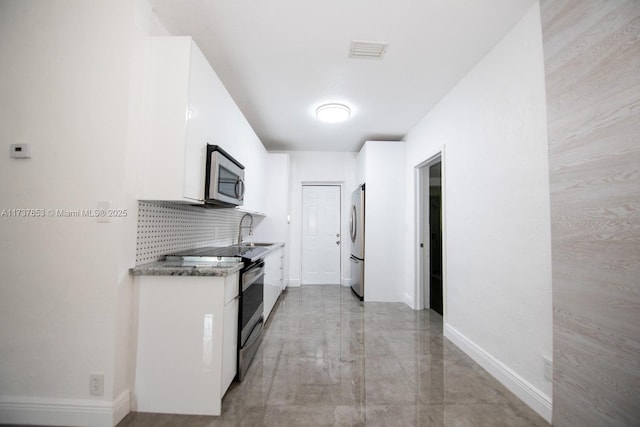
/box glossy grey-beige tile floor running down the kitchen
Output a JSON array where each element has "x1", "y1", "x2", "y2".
[{"x1": 118, "y1": 286, "x2": 548, "y2": 427}]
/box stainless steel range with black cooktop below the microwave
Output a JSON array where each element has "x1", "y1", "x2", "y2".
[{"x1": 166, "y1": 245, "x2": 269, "y2": 381}]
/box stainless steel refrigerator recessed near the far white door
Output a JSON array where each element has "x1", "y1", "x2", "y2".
[{"x1": 349, "y1": 184, "x2": 365, "y2": 299}]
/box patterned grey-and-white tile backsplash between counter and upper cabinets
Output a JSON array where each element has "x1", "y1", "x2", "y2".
[{"x1": 136, "y1": 201, "x2": 244, "y2": 265}]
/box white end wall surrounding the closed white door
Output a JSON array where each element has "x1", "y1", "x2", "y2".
[{"x1": 289, "y1": 151, "x2": 357, "y2": 286}]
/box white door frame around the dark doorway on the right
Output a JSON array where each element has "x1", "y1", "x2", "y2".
[{"x1": 414, "y1": 149, "x2": 447, "y2": 320}]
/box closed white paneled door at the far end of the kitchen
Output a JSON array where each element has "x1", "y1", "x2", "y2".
[{"x1": 301, "y1": 185, "x2": 341, "y2": 285}]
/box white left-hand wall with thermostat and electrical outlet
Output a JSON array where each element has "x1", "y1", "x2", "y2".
[{"x1": 0, "y1": 0, "x2": 151, "y2": 425}]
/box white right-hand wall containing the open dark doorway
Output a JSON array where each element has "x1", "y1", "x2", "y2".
[{"x1": 405, "y1": 3, "x2": 552, "y2": 418}]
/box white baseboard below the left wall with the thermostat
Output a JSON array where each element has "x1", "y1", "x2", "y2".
[{"x1": 0, "y1": 390, "x2": 131, "y2": 427}]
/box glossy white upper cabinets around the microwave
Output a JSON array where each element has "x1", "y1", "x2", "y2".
[{"x1": 139, "y1": 37, "x2": 267, "y2": 212}]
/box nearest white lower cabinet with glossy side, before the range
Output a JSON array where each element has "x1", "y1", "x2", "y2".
[{"x1": 134, "y1": 273, "x2": 238, "y2": 415}]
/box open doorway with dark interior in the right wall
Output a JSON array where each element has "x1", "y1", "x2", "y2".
[{"x1": 416, "y1": 153, "x2": 444, "y2": 316}]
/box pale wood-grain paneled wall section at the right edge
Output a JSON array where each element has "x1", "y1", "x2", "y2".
[{"x1": 540, "y1": 0, "x2": 640, "y2": 426}]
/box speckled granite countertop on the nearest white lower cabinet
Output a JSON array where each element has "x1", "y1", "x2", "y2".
[{"x1": 129, "y1": 261, "x2": 244, "y2": 276}]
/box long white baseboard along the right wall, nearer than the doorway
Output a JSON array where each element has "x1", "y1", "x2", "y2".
[{"x1": 444, "y1": 324, "x2": 552, "y2": 423}]
